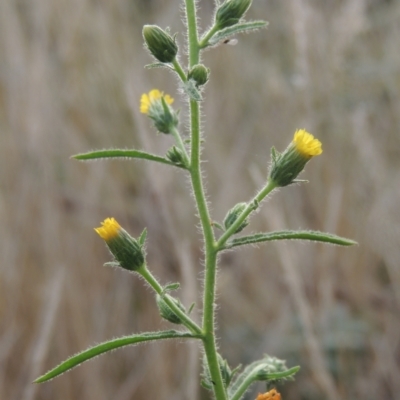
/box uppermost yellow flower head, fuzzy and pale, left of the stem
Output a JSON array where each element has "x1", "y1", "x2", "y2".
[{"x1": 140, "y1": 89, "x2": 179, "y2": 134}]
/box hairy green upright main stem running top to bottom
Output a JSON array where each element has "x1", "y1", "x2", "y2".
[{"x1": 185, "y1": 0, "x2": 227, "y2": 400}]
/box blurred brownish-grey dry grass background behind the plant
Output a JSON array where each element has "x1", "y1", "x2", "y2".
[{"x1": 0, "y1": 0, "x2": 400, "y2": 400}]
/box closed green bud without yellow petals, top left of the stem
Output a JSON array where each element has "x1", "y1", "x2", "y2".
[{"x1": 143, "y1": 25, "x2": 178, "y2": 63}]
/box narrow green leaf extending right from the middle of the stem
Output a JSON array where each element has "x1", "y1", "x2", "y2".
[{"x1": 225, "y1": 231, "x2": 357, "y2": 249}]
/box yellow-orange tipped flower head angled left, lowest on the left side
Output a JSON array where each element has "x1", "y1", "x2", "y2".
[{"x1": 95, "y1": 218, "x2": 145, "y2": 271}]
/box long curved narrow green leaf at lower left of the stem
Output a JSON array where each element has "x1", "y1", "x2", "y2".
[{"x1": 34, "y1": 330, "x2": 197, "y2": 383}]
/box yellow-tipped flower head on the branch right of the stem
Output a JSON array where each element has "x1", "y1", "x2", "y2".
[{"x1": 269, "y1": 129, "x2": 322, "y2": 186}]
